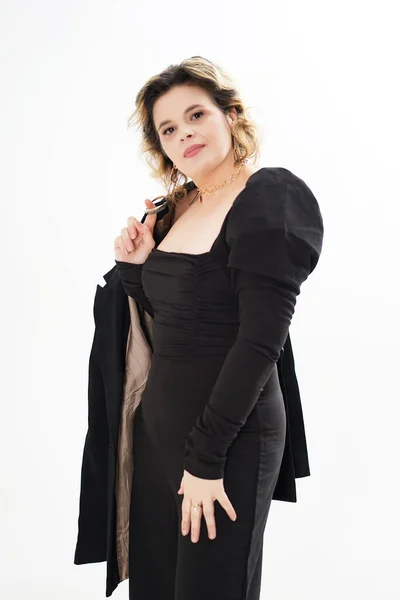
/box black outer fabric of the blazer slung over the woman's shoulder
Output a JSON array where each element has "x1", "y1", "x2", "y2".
[{"x1": 74, "y1": 182, "x2": 322, "y2": 597}]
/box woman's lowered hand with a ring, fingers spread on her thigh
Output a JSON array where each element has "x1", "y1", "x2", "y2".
[{"x1": 178, "y1": 471, "x2": 237, "y2": 542}]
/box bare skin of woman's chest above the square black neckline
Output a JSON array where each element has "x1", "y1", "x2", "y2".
[{"x1": 158, "y1": 186, "x2": 244, "y2": 254}]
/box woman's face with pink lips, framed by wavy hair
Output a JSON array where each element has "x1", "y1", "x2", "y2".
[{"x1": 153, "y1": 85, "x2": 236, "y2": 180}]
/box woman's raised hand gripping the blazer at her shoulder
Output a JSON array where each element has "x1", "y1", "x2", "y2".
[{"x1": 114, "y1": 200, "x2": 157, "y2": 264}]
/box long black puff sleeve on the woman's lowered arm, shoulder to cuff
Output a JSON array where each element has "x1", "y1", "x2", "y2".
[{"x1": 184, "y1": 169, "x2": 323, "y2": 479}]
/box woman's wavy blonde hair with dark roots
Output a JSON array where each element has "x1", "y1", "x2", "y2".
[{"x1": 128, "y1": 56, "x2": 260, "y2": 206}]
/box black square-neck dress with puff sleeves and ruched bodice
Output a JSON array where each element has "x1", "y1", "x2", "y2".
[{"x1": 116, "y1": 167, "x2": 322, "y2": 600}]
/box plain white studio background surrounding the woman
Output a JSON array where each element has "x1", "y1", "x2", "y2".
[{"x1": 0, "y1": 0, "x2": 400, "y2": 600}]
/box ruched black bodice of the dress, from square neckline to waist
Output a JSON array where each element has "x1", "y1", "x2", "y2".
[{"x1": 142, "y1": 243, "x2": 239, "y2": 360}]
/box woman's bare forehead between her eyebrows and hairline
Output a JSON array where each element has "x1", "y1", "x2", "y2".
[{"x1": 153, "y1": 85, "x2": 212, "y2": 125}]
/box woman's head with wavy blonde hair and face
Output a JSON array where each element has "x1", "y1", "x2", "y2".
[{"x1": 128, "y1": 56, "x2": 260, "y2": 207}]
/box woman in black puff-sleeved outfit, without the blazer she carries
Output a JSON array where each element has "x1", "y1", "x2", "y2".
[{"x1": 114, "y1": 57, "x2": 323, "y2": 600}]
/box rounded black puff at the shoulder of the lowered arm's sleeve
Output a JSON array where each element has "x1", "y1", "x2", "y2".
[{"x1": 225, "y1": 167, "x2": 324, "y2": 270}]
